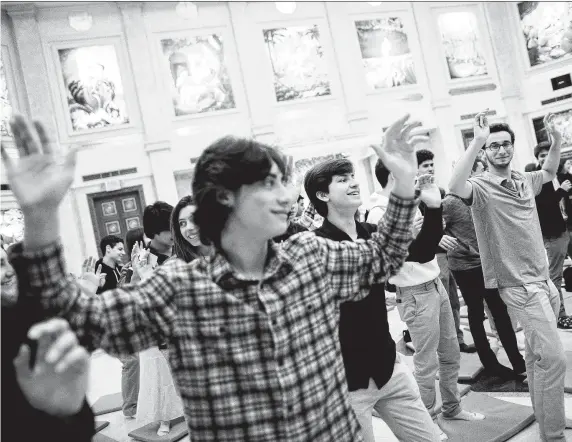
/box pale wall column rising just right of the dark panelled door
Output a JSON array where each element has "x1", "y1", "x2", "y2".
[{"x1": 117, "y1": 2, "x2": 178, "y2": 205}]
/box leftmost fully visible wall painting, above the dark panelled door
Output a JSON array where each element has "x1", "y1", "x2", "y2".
[{"x1": 57, "y1": 44, "x2": 129, "y2": 132}]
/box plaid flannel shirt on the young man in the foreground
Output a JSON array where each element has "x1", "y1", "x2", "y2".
[{"x1": 11, "y1": 195, "x2": 417, "y2": 442}]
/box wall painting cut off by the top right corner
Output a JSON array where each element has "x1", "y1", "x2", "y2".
[{"x1": 517, "y1": 2, "x2": 572, "y2": 67}]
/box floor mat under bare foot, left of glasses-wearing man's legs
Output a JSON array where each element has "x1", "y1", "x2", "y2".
[{"x1": 437, "y1": 392, "x2": 534, "y2": 442}]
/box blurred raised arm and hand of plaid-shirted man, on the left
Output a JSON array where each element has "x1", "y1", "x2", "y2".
[{"x1": 2, "y1": 116, "x2": 181, "y2": 353}]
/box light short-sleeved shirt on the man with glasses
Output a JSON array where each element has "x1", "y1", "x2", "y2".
[{"x1": 466, "y1": 171, "x2": 549, "y2": 288}]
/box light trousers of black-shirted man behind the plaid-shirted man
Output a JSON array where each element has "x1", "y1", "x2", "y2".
[{"x1": 349, "y1": 353, "x2": 439, "y2": 442}]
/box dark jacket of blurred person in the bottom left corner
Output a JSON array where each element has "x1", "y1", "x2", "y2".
[{"x1": 0, "y1": 264, "x2": 95, "y2": 442}]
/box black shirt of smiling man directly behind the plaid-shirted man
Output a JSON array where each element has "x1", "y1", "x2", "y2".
[{"x1": 314, "y1": 219, "x2": 395, "y2": 391}]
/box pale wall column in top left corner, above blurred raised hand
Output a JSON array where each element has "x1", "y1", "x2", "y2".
[{"x1": 3, "y1": 3, "x2": 57, "y2": 139}]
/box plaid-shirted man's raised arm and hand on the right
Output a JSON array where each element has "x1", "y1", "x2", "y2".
[{"x1": 297, "y1": 116, "x2": 427, "y2": 302}]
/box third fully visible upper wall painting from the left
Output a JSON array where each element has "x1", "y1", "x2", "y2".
[{"x1": 262, "y1": 25, "x2": 331, "y2": 102}]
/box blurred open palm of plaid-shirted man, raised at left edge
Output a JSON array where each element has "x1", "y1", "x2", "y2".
[{"x1": 2, "y1": 116, "x2": 76, "y2": 212}]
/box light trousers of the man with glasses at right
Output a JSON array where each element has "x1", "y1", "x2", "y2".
[{"x1": 499, "y1": 280, "x2": 566, "y2": 442}]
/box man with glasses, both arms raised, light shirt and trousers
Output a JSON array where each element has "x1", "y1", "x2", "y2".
[{"x1": 449, "y1": 112, "x2": 566, "y2": 442}]
